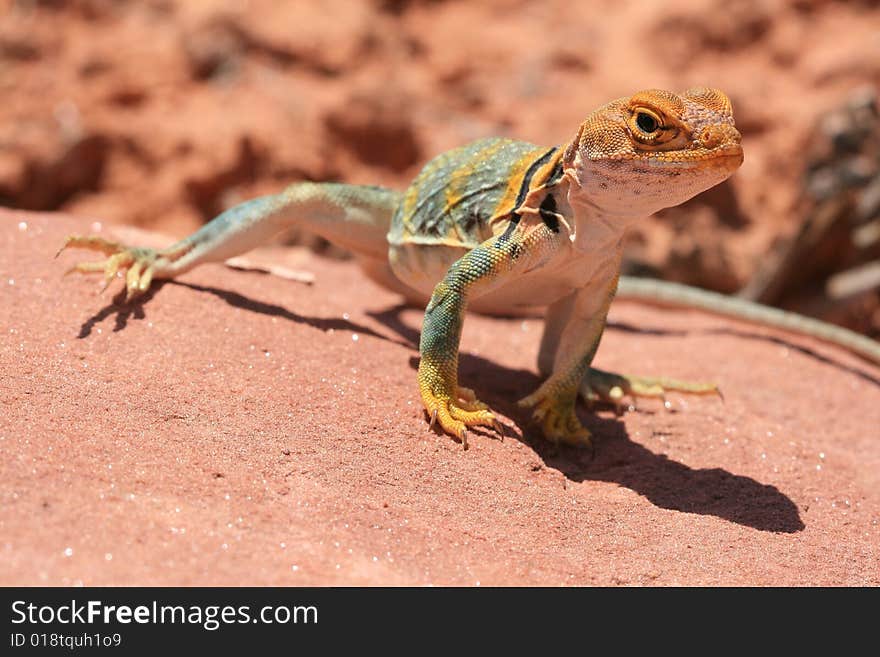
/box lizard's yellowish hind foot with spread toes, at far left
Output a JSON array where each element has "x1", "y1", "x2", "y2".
[{"x1": 55, "y1": 235, "x2": 162, "y2": 301}]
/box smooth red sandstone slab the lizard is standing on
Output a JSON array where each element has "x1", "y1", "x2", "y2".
[{"x1": 0, "y1": 211, "x2": 880, "y2": 586}]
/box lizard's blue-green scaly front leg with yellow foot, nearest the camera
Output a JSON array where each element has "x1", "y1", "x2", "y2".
[{"x1": 419, "y1": 225, "x2": 558, "y2": 448}]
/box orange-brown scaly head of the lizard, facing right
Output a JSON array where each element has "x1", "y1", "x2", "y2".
[{"x1": 563, "y1": 87, "x2": 743, "y2": 217}]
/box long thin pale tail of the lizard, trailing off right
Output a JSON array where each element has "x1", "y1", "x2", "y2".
[{"x1": 617, "y1": 276, "x2": 880, "y2": 364}]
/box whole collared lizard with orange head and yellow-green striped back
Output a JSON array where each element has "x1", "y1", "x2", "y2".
[{"x1": 59, "y1": 87, "x2": 880, "y2": 449}]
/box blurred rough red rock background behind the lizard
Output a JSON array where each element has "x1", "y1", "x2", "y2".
[{"x1": 0, "y1": 0, "x2": 880, "y2": 336}]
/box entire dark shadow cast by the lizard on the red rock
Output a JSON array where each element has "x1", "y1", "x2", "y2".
[{"x1": 78, "y1": 292, "x2": 804, "y2": 533}]
